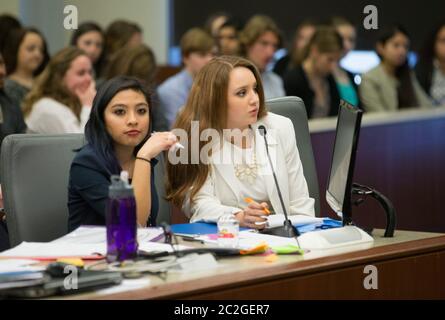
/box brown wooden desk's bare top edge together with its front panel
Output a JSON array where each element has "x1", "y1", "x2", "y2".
[{"x1": 59, "y1": 230, "x2": 445, "y2": 299}]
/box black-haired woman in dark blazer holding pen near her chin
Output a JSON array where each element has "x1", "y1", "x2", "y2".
[{"x1": 68, "y1": 76, "x2": 177, "y2": 231}]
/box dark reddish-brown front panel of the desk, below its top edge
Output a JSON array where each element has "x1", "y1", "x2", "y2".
[{"x1": 185, "y1": 252, "x2": 445, "y2": 300}]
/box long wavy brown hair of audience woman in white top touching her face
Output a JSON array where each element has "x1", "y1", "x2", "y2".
[{"x1": 23, "y1": 47, "x2": 87, "y2": 121}]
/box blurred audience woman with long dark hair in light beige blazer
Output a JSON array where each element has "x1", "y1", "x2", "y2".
[{"x1": 359, "y1": 26, "x2": 431, "y2": 112}]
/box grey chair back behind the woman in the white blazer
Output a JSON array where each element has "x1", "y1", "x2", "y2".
[{"x1": 266, "y1": 97, "x2": 320, "y2": 217}]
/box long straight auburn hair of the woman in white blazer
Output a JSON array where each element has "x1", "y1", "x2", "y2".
[{"x1": 166, "y1": 56, "x2": 267, "y2": 207}]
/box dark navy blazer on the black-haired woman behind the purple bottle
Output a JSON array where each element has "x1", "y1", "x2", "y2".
[{"x1": 68, "y1": 144, "x2": 159, "y2": 232}]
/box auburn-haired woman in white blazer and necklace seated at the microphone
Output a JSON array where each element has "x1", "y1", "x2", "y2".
[{"x1": 167, "y1": 56, "x2": 314, "y2": 229}]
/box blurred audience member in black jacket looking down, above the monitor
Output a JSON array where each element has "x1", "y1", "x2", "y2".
[{"x1": 284, "y1": 26, "x2": 343, "y2": 118}]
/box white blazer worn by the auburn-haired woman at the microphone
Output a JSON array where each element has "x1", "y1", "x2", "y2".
[{"x1": 186, "y1": 112, "x2": 315, "y2": 222}]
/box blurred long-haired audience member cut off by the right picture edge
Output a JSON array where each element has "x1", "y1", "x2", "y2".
[{"x1": 416, "y1": 20, "x2": 445, "y2": 106}]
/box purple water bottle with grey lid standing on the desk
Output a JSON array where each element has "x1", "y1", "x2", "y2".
[{"x1": 106, "y1": 171, "x2": 138, "y2": 262}]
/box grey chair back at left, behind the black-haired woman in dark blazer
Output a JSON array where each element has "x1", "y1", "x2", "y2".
[{"x1": 0, "y1": 134, "x2": 84, "y2": 247}]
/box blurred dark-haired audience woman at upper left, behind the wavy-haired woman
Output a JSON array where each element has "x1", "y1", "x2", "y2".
[{"x1": 3, "y1": 28, "x2": 49, "y2": 105}]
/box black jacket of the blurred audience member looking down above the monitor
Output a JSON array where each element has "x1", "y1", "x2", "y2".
[{"x1": 284, "y1": 65, "x2": 340, "y2": 118}]
